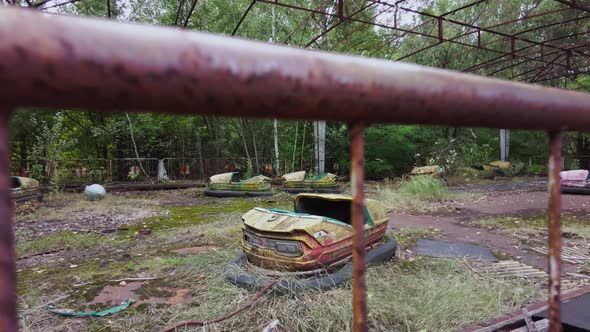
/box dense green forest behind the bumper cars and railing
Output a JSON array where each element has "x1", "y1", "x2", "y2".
[{"x1": 11, "y1": 0, "x2": 590, "y2": 181}]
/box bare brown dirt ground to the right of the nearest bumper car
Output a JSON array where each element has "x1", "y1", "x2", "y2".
[{"x1": 389, "y1": 180, "x2": 590, "y2": 272}]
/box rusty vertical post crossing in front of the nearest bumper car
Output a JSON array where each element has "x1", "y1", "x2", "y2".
[{"x1": 349, "y1": 122, "x2": 367, "y2": 332}]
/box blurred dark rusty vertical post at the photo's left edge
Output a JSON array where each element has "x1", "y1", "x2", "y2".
[{"x1": 0, "y1": 107, "x2": 18, "y2": 331}]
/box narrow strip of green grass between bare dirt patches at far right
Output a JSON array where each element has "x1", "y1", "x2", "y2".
[{"x1": 473, "y1": 215, "x2": 590, "y2": 239}]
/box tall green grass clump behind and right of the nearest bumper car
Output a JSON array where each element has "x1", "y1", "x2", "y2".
[{"x1": 375, "y1": 175, "x2": 465, "y2": 212}]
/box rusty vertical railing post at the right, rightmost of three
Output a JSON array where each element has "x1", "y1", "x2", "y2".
[{"x1": 548, "y1": 131, "x2": 562, "y2": 332}]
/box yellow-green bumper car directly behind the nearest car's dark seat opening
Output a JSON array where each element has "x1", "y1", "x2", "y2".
[{"x1": 283, "y1": 171, "x2": 340, "y2": 194}]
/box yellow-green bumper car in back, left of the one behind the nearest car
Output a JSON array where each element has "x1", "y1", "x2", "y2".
[{"x1": 205, "y1": 172, "x2": 273, "y2": 197}]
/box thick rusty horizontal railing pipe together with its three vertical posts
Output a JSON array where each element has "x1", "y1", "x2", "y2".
[{"x1": 0, "y1": 8, "x2": 590, "y2": 331}]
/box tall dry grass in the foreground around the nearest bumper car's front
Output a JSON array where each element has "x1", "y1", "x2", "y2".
[{"x1": 71, "y1": 255, "x2": 543, "y2": 331}]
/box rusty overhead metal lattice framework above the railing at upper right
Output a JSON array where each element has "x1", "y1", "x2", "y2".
[{"x1": 230, "y1": 0, "x2": 590, "y2": 90}]
